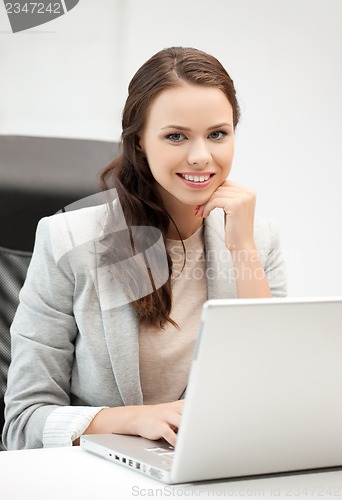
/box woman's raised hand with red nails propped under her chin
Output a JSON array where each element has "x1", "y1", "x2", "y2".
[{"x1": 196, "y1": 181, "x2": 256, "y2": 251}]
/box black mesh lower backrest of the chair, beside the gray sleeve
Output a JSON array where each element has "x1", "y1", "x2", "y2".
[{"x1": 0, "y1": 247, "x2": 31, "y2": 450}]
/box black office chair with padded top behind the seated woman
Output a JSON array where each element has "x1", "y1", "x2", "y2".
[{"x1": 0, "y1": 136, "x2": 118, "y2": 450}]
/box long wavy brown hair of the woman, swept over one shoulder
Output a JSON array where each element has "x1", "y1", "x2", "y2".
[{"x1": 100, "y1": 47, "x2": 240, "y2": 328}]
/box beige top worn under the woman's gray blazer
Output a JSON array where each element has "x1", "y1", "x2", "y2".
[{"x1": 139, "y1": 226, "x2": 208, "y2": 404}]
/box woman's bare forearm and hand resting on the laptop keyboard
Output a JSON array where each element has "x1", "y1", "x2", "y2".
[{"x1": 81, "y1": 400, "x2": 184, "y2": 446}]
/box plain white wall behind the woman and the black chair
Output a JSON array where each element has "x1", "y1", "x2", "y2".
[{"x1": 0, "y1": 0, "x2": 342, "y2": 296}]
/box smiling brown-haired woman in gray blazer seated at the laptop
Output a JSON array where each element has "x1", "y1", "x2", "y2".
[{"x1": 4, "y1": 48, "x2": 285, "y2": 449}]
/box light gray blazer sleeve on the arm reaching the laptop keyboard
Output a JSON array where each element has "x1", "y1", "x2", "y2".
[{"x1": 3, "y1": 217, "x2": 99, "y2": 449}]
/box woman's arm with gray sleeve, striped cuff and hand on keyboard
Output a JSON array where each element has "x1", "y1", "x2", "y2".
[{"x1": 3, "y1": 215, "x2": 183, "y2": 449}]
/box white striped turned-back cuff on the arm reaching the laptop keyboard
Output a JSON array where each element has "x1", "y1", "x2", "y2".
[{"x1": 43, "y1": 406, "x2": 107, "y2": 448}]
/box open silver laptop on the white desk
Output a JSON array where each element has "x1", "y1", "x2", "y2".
[{"x1": 81, "y1": 297, "x2": 342, "y2": 484}]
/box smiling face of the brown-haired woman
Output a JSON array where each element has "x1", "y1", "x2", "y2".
[{"x1": 140, "y1": 83, "x2": 234, "y2": 210}]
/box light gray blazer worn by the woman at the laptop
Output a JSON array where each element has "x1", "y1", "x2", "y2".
[{"x1": 3, "y1": 206, "x2": 286, "y2": 449}]
